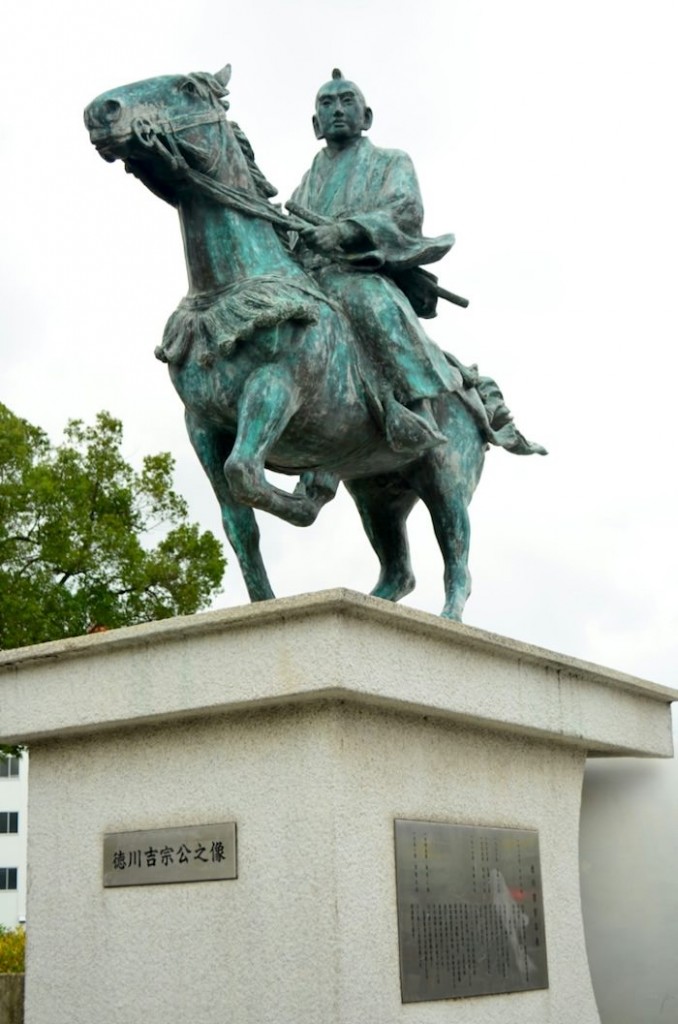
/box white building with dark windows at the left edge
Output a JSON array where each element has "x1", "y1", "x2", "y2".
[{"x1": 0, "y1": 754, "x2": 29, "y2": 928}]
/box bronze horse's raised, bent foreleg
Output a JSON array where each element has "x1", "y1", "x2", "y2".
[{"x1": 223, "y1": 365, "x2": 338, "y2": 526}]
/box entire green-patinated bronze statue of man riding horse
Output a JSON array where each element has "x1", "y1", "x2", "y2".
[{"x1": 85, "y1": 67, "x2": 545, "y2": 620}]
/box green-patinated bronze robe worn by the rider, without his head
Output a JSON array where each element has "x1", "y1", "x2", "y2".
[{"x1": 292, "y1": 137, "x2": 462, "y2": 404}]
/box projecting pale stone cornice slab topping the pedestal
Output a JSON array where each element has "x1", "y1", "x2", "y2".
[{"x1": 0, "y1": 590, "x2": 678, "y2": 757}]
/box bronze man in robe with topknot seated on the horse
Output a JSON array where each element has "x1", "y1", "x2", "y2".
[{"x1": 289, "y1": 69, "x2": 464, "y2": 453}]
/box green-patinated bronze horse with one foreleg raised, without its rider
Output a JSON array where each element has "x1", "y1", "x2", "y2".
[{"x1": 85, "y1": 69, "x2": 544, "y2": 620}]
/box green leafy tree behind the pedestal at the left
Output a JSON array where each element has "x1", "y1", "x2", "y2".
[{"x1": 0, "y1": 404, "x2": 225, "y2": 649}]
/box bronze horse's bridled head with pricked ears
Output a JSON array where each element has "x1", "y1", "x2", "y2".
[{"x1": 84, "y1": 65, "x2": 262, "y2": 206}]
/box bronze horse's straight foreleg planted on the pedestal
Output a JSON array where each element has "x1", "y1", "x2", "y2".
[{"x1": 185, "y1": 412, "x2": 276, "y2": 601}]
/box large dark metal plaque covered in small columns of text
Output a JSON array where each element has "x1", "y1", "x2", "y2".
[{"x1": 395, "y1": 820, "x2": 549, "y2": 1002}]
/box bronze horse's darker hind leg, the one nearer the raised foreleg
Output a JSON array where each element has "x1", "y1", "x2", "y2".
[{"x1": 344, "y1": 476, "x2": 417, "y2": 601}]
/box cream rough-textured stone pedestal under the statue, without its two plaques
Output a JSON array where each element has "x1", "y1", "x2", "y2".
[{"x1": 0, "y1": 591, "x2": 677, "y2": 1024}]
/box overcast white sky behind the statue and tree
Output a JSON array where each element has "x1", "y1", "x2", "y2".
[{"x1": 0, "y1": 0, "x2": 678, "y2": 685}]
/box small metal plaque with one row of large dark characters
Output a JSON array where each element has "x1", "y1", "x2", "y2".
[{"x1": 103, "y1": 821, "x2": 238, "y2": 888}]
